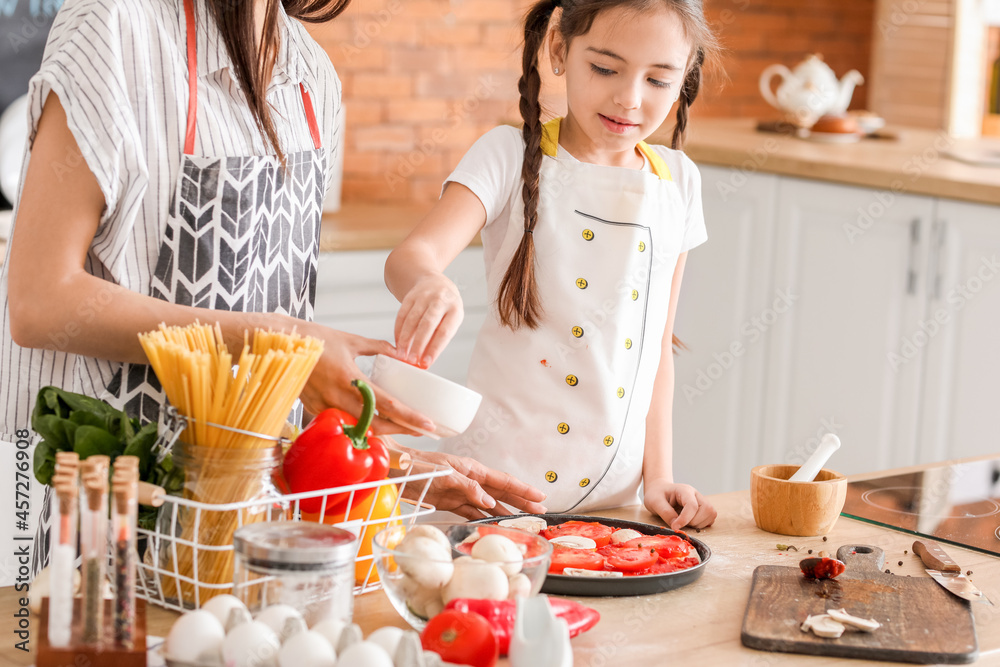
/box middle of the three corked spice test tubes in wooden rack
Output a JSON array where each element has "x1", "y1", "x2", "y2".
[{"x1": 80, "y1": 456, "x2": 109, "y2": 644}]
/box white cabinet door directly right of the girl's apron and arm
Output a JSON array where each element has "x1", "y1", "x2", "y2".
[{"x1": 673, "y1": 167, "x2": 778, "y2": 493}]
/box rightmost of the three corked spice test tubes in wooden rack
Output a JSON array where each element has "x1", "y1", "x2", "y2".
[{"x1": 111, "y1": 456, "x2": 139, "y2": 648}]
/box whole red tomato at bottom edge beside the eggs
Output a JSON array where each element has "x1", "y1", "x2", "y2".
[{"x1": 420, "y1": 609, "x2": 500, "y2": 667}]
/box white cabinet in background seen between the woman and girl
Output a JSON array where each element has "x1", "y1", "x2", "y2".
[{"x1": 316, "y1": 247, "x2": 487, "y2": 448}]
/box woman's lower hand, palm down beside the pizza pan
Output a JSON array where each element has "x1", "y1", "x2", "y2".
[{"x1": 390, "y1": 442, "x2": 546, "y2": 519}]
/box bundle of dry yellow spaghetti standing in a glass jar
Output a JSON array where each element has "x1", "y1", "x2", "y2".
[{"x1": 139, "y1": 324, "x2": 323, "y2": 607}]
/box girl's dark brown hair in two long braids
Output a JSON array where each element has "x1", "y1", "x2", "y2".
[{"x1": 497, "y1": 0, "x2": 718, "y2": 345}]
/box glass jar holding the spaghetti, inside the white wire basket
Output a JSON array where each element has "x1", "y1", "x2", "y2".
[{"x1": 156, "y1": 436, "x2": 288, "y2": 609}]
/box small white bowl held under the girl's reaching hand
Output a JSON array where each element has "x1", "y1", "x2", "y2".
[{"x1": 370, "y1": 354, "x2": 483, "y2": 438}]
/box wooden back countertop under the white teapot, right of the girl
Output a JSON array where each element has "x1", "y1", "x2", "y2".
[{"x1": 649, "y1": 118, "x2": 1000, "y2": 205}]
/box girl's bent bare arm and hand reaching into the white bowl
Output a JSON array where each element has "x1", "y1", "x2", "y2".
[{"x1": 385, "y1": 183, "x2": 486, "y2": 368}]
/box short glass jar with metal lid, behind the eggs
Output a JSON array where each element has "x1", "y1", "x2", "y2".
[{"x1": 233, "y1": 521, "x2": 357, "y2": 627}]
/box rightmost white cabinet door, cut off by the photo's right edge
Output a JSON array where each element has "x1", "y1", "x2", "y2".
[{"x1": 907, "y1": 200, "x2": 1000, "y2": 461}]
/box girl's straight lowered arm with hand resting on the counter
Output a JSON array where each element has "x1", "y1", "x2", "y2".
[{"x1": 642, "y1": 252, "x2": 716, "y2": 530}]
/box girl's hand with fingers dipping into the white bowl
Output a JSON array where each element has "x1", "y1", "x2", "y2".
[{"x1": 396, "y1": 273, "x2": 465, "y2": 368}]
